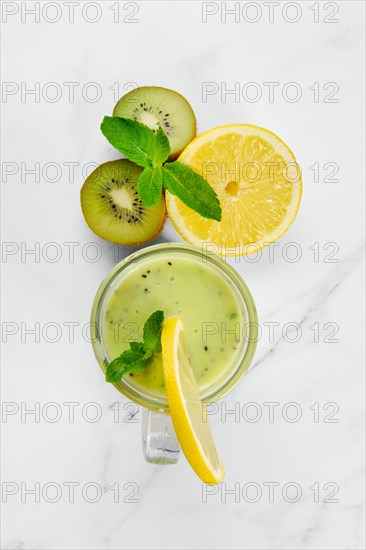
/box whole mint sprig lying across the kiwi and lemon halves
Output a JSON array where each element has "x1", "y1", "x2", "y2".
[{"x1": 100, "y1": 116, "x2": 222, "y2": 221}]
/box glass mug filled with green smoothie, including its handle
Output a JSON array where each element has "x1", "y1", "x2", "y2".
[{"x1": 91, "y1": 243, "x2": 258, "y2": 464}]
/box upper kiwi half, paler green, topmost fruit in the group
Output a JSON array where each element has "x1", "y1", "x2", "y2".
[{"x1": 113, "y1": 86, "x2": 196, "y2": 160}]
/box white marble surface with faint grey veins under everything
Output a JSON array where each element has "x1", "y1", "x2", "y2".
[{"x1": 1, "y1": 0, "x2": 364, "y2": 550}]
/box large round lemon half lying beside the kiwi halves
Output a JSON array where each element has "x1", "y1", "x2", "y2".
[{"x1": 166, "y1": 124, "x2": 302, "y2": 256}]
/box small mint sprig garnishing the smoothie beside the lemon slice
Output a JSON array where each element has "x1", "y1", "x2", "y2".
[{"x1": 106, "y1": 310, "x2": 164, "y2": 382}]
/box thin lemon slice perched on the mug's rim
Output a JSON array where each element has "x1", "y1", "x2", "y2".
[{"x1": 161, "y1": 317, "x2": 225, "y2": 484}]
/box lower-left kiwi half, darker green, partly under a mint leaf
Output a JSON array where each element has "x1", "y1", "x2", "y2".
[{"x1": 81, "y1": 159, "x2": 165, "y2": 245}]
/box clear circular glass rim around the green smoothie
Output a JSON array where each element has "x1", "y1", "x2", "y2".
[{"x1": 91, "y1": 243, "x2": 258, "y2": 412}]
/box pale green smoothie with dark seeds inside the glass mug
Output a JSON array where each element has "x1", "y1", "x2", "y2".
[{"x1": 101, "y1": 251, "x2": 246, "y2": 395}]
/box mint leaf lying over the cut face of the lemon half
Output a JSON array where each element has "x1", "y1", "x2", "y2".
[{"x1": 163, "y1": 161, "x2": 222, "y2": 221}]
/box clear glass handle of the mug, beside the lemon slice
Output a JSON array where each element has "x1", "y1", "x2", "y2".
[{"x1": 142, "y1": 408, "x2": 180, "y2": 464}]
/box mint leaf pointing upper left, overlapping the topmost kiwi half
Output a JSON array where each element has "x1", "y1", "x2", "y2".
[{"x1": 100, "y1": 116, "x2": 156, "y2": 168}]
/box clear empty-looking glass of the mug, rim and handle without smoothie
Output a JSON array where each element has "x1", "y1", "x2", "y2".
[{"x1": 91, "y1": 243, "x2": 258, "y2": 464}]
